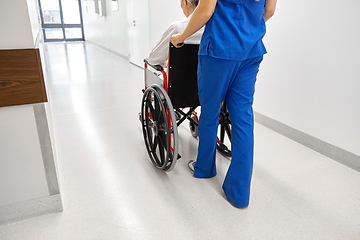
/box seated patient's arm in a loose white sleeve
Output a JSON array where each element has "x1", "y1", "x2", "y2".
[{"x1": 148, "y1": 24, "x2": 177, "y2": 68}]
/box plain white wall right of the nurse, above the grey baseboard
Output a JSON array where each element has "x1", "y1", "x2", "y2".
[{"x1": 254, "y1": 0, "x2": 360, "y2": 158}]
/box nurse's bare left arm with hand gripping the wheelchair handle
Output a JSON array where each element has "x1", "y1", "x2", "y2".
[{"x1": 170, "y1": 0, "x2": 217, "y2": 47}]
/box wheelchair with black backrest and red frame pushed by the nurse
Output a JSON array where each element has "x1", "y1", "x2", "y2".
[{"x1": 139, "y1": 43, "x2": 231, "y2": 171}]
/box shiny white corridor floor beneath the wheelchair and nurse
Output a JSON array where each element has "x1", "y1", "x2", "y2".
[{"x1": 0, "y1": 43, "x2": 360, "y2": 240}]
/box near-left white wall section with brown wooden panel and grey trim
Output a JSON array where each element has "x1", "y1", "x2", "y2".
[{"x1": 0, "y1": 0, "x2": 62, "y2": 225}]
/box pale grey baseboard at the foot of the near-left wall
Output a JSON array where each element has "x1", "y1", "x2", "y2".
[{"x1": 0, "y1": 194, "x2": 63, "y2": 226}]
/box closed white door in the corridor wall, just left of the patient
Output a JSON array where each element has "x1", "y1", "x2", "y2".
[{"x1": 127, "y1": 0, "x2": 150, "y2": 67}]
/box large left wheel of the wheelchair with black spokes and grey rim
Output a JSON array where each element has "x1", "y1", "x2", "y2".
[{"x1": 141, "y1": 84, "x2": 178, "y2": 171}]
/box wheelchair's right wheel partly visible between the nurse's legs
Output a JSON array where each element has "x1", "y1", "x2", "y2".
[{"x1": 217, "y1": 102, "x2": 232, "y2": 157}]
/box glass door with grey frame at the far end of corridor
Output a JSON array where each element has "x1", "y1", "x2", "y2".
[{"x1": 39, "y1": 0, "x2": 84, "y2": 42}]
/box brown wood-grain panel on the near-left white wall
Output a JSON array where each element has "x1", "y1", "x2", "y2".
[{"x1": 0, "y1": 49, "x2": 47, "y2": 107}]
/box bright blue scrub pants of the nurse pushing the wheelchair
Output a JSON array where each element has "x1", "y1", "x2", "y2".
[{"x1": 194, "y1": 55, "x2": 263, "y2": 207}]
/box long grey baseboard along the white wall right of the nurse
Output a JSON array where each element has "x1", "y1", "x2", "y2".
[{"x1": 254, "y1": 112, "x2": 360, "y2": 172}]
